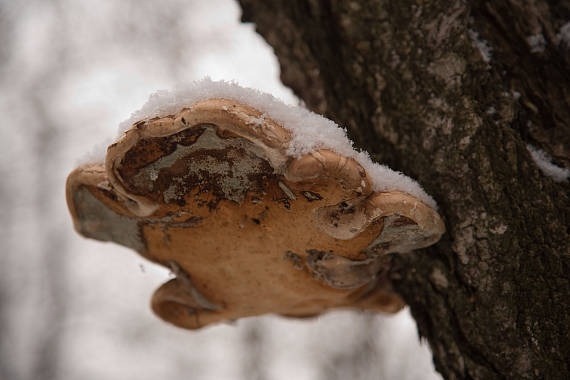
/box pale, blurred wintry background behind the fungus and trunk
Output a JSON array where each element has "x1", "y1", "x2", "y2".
[{"x1": 0, "y1": 0, "x2": 439, "y2": 380}]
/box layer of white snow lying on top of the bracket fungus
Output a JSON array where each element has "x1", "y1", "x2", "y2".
[{"x1": 115, "y1": 77, "x2": 437, "y2": 208}]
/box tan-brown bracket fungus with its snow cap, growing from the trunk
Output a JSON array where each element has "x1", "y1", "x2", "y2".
[{"x1": 66, "y1": 80, "x2": 444, "y2": 329}]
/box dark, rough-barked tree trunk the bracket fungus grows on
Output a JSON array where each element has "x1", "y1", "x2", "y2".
[{"x1": 236, "y1": 0, "x2": 570, "y2": 379}]
